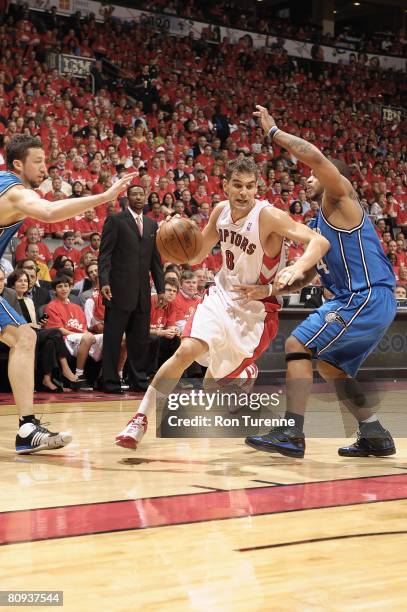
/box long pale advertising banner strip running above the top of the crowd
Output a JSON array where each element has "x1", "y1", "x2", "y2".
[{"x1": 14, "y1": 0, "x2": 407, "y2": 72}]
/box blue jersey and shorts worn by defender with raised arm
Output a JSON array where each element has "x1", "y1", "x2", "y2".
[{"x1": 292, "y1": 209, "x2": 396, "y2": 376}]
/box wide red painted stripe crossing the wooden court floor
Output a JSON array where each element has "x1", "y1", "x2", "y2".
[{"x1": 0, "y1": 474, "x2": 407, "y2": 545}]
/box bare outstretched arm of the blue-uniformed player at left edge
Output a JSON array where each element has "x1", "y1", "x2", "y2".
[{"x1": 1, "y1": 173, "x2": 137, "y2": 224}]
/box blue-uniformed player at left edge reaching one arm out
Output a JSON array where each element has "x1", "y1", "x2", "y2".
[{"x1": 0, "y1": 135, "x2": 136, "y2": 454}]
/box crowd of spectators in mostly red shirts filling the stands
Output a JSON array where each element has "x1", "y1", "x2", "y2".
[{"x1": 0, "y1": 3, "x2": 407, "y2": 388}]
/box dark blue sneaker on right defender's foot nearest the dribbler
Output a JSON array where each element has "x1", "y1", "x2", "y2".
[{"x1": 245, "y1": 426, "x2": 305, "y2": 459}]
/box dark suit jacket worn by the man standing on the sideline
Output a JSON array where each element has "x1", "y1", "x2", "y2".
[{"x1": 98, "y1": 209, "x2": 164, "y2": 313}]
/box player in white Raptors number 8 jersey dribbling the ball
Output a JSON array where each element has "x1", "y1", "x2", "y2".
[{"x1": 116, "y1": 158, "x2": 330, "y2": 449}]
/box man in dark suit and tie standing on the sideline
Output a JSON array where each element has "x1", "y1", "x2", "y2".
[{"x1": 99, "y1": 185, "x2": 165, "y2": 393}]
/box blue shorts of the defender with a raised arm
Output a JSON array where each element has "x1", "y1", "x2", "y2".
[{"x1": 292, "y1": 286, "x2": 397, "y2": 376}]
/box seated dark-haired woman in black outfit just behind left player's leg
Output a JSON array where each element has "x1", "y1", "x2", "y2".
[{"x1": 7, "y1": 270, "x2": 76, "y2": 393}]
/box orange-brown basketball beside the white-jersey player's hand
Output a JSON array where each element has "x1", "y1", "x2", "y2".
[{"x1": 157, "y1": 218, "x2": 202, "y2": 264}]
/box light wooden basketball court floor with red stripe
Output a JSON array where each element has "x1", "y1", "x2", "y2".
[{"x1": 0, "y1": 383, "x2": 407, "y2": 612}]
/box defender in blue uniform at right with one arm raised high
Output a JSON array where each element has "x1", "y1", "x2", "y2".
[{"x1": 239, "y1": 106, "x2": 396, "y2": 458}]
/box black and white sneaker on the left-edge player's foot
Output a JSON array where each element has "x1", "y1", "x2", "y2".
[{"x1": 16, "y1": 419, "x2": 72, "y2": 455}]
